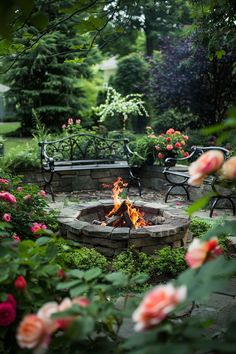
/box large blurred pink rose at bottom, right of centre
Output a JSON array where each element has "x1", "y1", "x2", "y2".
[{"x1": 133, "y1": 283, "x2": 187, "y2": 331}]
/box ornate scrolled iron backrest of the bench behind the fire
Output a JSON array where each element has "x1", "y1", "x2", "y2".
[{"x1": 39, "y1": 133, "x2": 129, "y2": 161}]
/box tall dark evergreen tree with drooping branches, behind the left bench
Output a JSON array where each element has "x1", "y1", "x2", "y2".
[{"x1": 5, "y1": 0, "x2": 95, "y2": 134}]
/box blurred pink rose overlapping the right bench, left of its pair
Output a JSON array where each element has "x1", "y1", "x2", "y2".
[{"x1": 188, "y1": 150, "x2": 224, "y2": 186}]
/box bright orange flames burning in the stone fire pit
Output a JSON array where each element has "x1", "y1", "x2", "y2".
[{"x1": 108, "y1": 177, "x2": 148, "y2": 229}]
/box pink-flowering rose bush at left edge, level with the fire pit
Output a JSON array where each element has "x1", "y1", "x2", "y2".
[{"x1": 0, "y1": 177, "x2": 57, "y2": 239}]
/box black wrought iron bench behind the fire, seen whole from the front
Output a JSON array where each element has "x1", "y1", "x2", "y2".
[{"x1": 39, "y1": 133, "x2": 142, "y2": 201}]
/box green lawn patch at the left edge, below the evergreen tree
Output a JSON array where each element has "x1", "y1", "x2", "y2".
[{"x1": 0, "y1": 122, "x2": 31, "y2": 155}]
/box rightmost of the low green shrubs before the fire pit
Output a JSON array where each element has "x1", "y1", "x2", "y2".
[{"x1": 152, "y1": 246, "x2": 187, "y2": 277}]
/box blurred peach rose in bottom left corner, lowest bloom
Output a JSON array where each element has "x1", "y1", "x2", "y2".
[{"x1": 16, "y1": 315, "x2": 50, "y2": 349}]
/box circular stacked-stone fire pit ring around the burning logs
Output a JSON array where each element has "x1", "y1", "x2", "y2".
[{"x1": 59, "y1": 200, "x2": 189, "y2": 257}]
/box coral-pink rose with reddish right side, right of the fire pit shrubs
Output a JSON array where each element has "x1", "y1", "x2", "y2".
[{"x1": 185, "y1": 237, "x2": 223, "y2": 268}]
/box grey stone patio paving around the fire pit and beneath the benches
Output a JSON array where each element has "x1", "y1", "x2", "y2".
[{"x1": 50, "y1": 189, "x2": 236, "y2": 336}]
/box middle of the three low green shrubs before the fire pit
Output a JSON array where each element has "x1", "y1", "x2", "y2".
[{"x1": 112, "y1": 249, "x2": 152, "y2": 275}]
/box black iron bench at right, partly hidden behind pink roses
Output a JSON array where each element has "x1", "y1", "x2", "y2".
[{"x1": 163, "y1": 146, "x2": 236, "y2": 217}]
